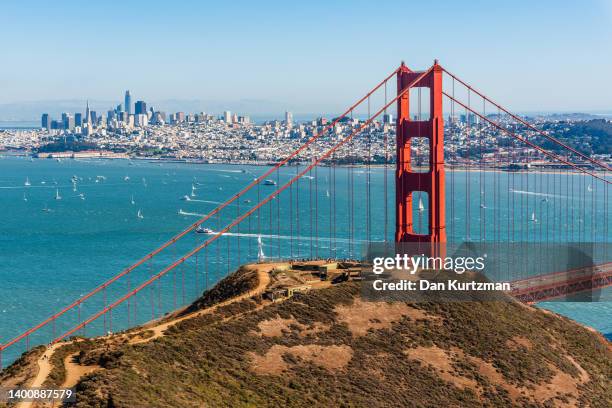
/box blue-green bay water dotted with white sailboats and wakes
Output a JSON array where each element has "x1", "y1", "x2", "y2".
[{"x1": 0, "y1": 157, "x2": 612, "y2": 364}]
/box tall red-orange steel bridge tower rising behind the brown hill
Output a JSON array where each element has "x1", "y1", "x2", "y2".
[{"x1": 395, "y1": 60, "x2": 446, "y2": 244}]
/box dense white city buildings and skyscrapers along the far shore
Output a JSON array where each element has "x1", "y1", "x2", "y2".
[{"x1": 0, "y1": 91, "x2": 612, "y2": 168}]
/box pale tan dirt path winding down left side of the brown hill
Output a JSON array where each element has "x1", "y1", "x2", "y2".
[{"x1": 16, "y1": 264, "x2": 278, "y2": 408}]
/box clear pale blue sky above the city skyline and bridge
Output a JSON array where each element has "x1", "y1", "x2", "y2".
[{"x1": 0, "y1": 0, "x2": 612, "y2": 113}]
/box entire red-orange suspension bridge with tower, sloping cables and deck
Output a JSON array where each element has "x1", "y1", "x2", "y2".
[{"x1": 0, "y1": 61, "x2": 612, "y2": 368}]
